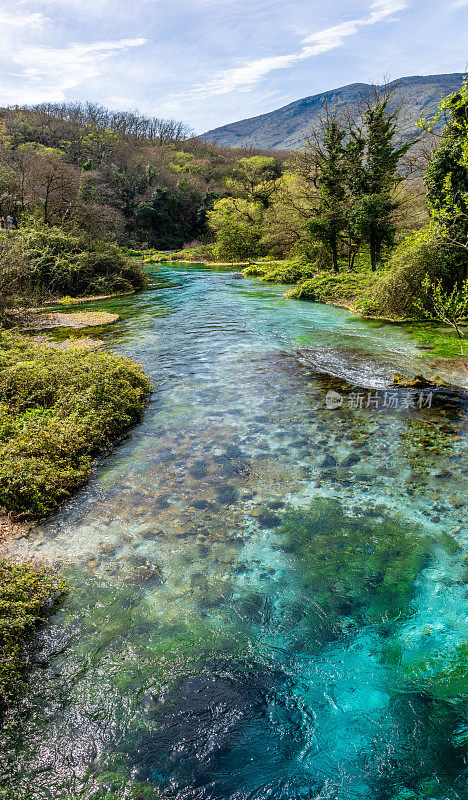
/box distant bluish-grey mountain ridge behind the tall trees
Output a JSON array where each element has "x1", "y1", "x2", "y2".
[{"x1": 201, "y1": 73, "x2": 464, "y2": 150}]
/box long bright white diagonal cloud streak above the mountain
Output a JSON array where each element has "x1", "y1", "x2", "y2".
[{"x1": 195, "y1": 0, "x2": 406, "y2": 97}]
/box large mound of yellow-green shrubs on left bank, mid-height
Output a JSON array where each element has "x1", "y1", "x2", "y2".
[{"x1": 0, "y1": 333, "x2": 150, "y2": 517}]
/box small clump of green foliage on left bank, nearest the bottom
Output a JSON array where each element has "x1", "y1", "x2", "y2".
[{"x1": 0, "y1": 559, "x2": 66, "y2": 709}]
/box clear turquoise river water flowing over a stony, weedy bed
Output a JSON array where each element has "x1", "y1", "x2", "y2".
[{"x1": 0, "y1": 266, "x2": 468, "y2": 800}]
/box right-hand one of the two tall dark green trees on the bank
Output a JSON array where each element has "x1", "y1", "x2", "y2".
[{"x1": 345, "y1": 97, "x2": 410, "y2": 271}]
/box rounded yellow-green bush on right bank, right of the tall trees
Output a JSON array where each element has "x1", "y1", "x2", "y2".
[{"x1": 369, "y1": 228, "x2": 461, "y2": 317}]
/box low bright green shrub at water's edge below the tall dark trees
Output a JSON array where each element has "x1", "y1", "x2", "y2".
[{"x1": 286, "y1": 272, "x2": 375, "y2": 305}]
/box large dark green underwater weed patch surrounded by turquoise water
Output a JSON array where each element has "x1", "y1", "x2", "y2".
[{"x1": 279, "y1": 500, "x2": 429, "y2": 628}]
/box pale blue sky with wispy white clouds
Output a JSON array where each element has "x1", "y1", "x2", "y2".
[{"x1": 0, "y1": 0, "x2": 468, "y2": 133}]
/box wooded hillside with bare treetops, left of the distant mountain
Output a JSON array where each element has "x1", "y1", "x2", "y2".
[{"x1": 0, "y1": 103, "x2": 286, "y2": 249}]
